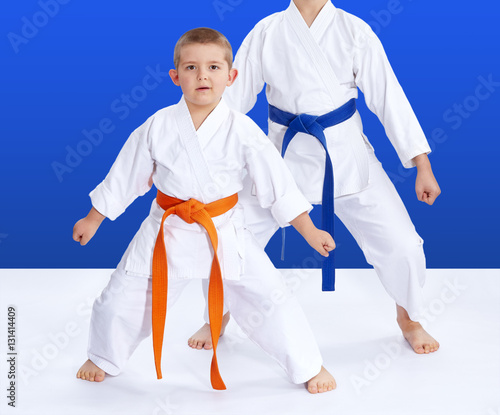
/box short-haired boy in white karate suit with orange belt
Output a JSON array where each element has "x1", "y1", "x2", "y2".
[{"x1": 73, "y1": 28, "x2": 335, "y2": 393}]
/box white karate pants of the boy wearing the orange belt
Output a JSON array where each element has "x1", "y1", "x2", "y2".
[{"x1": 88, "y1": 231, "x2": 322, "y2": 383}]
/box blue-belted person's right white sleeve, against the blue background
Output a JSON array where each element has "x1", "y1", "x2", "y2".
[{"x1": 354, "y1": 22, "x2": 431, "y2": 168}]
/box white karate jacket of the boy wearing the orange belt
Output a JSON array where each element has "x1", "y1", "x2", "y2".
[{"x1": 90, "y1": 97, "x2": 312, "y2": 279}]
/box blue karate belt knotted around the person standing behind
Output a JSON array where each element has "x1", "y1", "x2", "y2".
[{"x1": 269, "y1": 98, "x2": 356, "y2": 291}]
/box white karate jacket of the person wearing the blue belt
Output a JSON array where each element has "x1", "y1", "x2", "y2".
[{"x1": 224, "y1": 1, "x2": 431, "y2": 203}]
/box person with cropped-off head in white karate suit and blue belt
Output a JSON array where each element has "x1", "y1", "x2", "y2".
[{"x1": 188, "y1": 0, "x2": 441, "y2": 353}]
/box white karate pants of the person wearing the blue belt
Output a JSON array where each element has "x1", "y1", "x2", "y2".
[{"x1": 203, "y1": 148, "x2": 425, "y2": 322}]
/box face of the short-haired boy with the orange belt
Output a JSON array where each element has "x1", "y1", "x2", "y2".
[{"x1": 169, "y1": 43, "x2": 238, "y2": 112}]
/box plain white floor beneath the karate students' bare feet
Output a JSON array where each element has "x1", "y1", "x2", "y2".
[{"x1": 0, "y1": 269, "x2": 500, "y2": 415}]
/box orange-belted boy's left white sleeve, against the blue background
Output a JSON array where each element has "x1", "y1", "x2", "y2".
[{"x1": 90, "y1": 117, "x2": 154, "y2": 220}]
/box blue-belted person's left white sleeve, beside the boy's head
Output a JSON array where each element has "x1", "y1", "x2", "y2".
[{"x1": 224, "y1": 29, "x2": 264, "y2": 114}]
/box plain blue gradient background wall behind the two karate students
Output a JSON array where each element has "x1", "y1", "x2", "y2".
[{"x1": 0, "y1": 0, "x2": 500, "y2": 268}]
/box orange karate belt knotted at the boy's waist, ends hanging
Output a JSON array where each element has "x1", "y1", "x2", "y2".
[{"x1": 153, "y1": 190, "x2": 238, "y2": 390}]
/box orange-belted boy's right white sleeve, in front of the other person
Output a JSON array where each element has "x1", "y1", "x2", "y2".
[{"x1": 246, "y1": 129, "x2": 312, "y2": 227}]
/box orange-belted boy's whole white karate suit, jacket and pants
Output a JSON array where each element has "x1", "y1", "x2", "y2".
[{"x1": 88, "y1": 98, "x2": 322, "y2": 383}]
